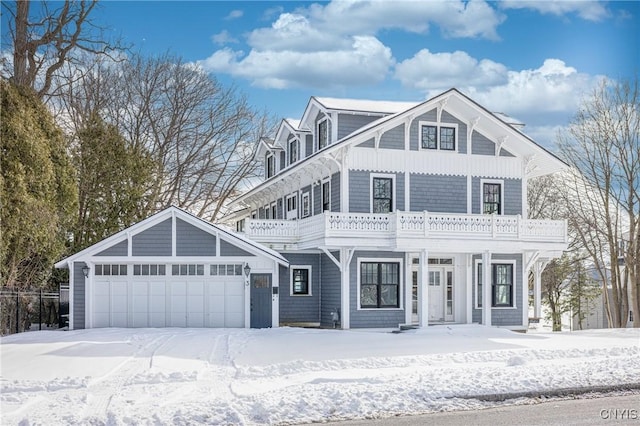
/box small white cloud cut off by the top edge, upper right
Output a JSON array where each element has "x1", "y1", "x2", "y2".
[{"x1": 499, "y1": 0, "x2": 611, "y2": 22}]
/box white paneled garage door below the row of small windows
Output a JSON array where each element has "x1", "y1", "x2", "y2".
[{"x1": 91, "y1": 276, "x2": 245, "y2": 327}]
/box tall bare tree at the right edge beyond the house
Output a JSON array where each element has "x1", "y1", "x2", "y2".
[{"x1": 558, "y1": 78, "x2": 640, "y2": 327}]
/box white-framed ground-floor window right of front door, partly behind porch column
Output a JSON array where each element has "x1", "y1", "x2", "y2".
[{"x1": 475, "y1": 259, "x2": 516, "y2": 309}]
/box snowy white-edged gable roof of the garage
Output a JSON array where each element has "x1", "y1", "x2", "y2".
[{"x1": 55, "y1": 206, "x2": 289, "y2": 268}]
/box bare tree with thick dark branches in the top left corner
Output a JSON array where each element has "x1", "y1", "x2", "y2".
[{"x1": 2, "y1": 0, "x2": 121, "y2": 98}]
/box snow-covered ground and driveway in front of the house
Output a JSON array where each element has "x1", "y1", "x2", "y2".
[{"x1": 0, "y1": 325, "x2": 640, "y2": 425}]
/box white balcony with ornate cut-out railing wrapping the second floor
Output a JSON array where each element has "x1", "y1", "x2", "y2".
[{"x1": 246, "y1": 212, "x2": 567, "y2": 251}]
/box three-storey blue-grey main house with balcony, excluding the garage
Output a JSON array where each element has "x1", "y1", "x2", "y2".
[{"x1": 227, "y1": 89, "x2": 567, "y2": 330}]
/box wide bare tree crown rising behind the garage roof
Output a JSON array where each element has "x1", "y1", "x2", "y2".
[{"x1": 59, "y1": 55, "x2": 274, "y2": 220}]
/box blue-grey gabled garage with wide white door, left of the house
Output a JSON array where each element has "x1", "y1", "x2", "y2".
[{"x1": 56, "y1": 207, "x2": 288, "y2": 328}]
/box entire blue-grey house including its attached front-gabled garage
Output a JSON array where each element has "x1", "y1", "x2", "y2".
[{"x1": 56, "y1": 89, "x2": 567, "y2": 329}]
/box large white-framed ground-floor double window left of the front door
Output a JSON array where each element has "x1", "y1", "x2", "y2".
[{"x1": 360, "y1": 262, "x2": 400, "y2": 308}]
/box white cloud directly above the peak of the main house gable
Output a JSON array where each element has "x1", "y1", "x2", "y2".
[{"x1": 395, "y1": 49, "x2": 508, "y2": 91}]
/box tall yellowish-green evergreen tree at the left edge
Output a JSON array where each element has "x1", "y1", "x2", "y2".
[{"x1": 0, "y1": 80, "x2": 77, "y2": 288}]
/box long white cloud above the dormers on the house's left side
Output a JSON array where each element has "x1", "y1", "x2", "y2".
[{"x1": 199, "y1": 36, "x2": 394, "y2": 89}]
